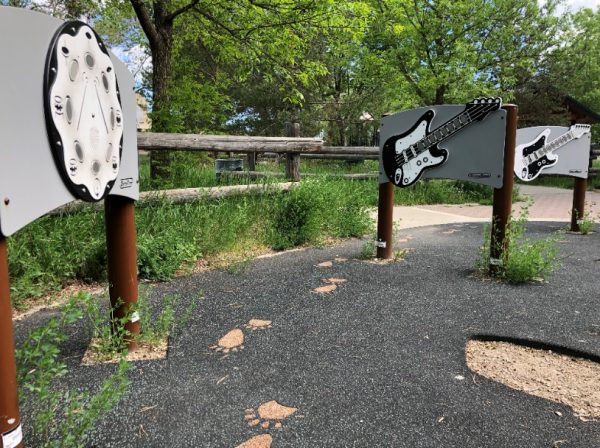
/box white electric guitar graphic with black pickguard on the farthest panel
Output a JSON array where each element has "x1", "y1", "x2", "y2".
[{"x1": 515, "y1": 124, "x2": 591, "y2": 182}]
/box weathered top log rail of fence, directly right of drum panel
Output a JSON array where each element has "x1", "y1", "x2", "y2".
[{"x1": 138, "y1": 132, "x2": 323, "y2": 153}]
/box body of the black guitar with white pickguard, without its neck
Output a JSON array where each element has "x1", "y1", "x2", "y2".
[{"x1": 382, "y1": 110, "x2": 448, "y2": 187}]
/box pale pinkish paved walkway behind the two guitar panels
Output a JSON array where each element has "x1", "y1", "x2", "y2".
[{"x1": 394, "y1": 185, "x2": 600, "y2": 229}]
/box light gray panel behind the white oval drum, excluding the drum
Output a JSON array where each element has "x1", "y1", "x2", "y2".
[{"x1": 0, "y1": 6, "x2": 139, "y2": 236}]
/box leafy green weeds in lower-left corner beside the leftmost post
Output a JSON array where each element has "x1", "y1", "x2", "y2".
[{"x1": 16, "y1": 294, "x2": 130, "y2": 448}]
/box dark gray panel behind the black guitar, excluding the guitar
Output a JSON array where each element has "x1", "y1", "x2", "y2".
[{"x1": 379, "y1": 105, "x2": 506, "y2": 188}]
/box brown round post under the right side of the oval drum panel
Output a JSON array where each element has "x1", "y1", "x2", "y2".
[{"x1": 104, "y1": 195, "x2": 140, "y2": 351}]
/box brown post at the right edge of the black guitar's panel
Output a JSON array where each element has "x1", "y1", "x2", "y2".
[{"x1": 489, "y1": 104, "x2": 518, "y2": 275}]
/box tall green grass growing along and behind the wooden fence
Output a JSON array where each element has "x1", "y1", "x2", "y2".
[{"x1": 8, "y1": 153, "x2": 506, "y2": 307}]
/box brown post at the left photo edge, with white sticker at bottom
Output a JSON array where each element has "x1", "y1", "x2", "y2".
[{"x1": 0, "y1": 235, "x2": 23, "y2": 448}]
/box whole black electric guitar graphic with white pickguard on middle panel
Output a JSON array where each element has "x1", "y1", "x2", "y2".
[{"x1": 381, "y1": 98, "x2": 502, "y2": 187}]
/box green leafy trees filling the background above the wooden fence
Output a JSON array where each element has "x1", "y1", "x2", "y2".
[{"x1": 1, "y1": 0, "x2": 600, "y2": 145}]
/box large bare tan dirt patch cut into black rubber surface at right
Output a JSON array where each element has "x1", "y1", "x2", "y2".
[{"x1": 465, "y1": 341, "x2": 600, "y2": 421}]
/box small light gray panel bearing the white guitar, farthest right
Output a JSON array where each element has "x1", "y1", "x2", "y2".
[{"x1": 515, "y1": 125, "x2": 592, "y2": 181}]
